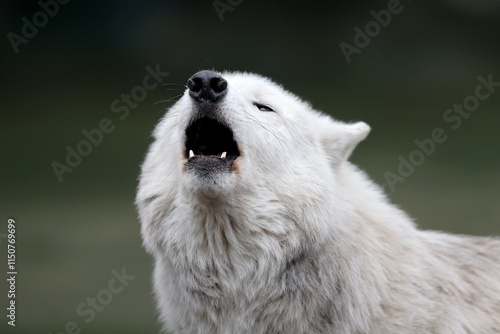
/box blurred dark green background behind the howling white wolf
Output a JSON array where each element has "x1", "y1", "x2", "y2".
[{"x1": 0, "y1": 0, "x2": 500, "y2": 334}]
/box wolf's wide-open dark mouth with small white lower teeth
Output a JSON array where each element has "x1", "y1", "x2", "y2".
[{"x1": 186, "y1": 117, "x2": 240, "y2": 166}]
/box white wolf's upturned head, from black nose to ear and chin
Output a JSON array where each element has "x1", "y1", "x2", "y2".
[{"x1": 139, "y1": 71, "x2": 370, "y2": 197}]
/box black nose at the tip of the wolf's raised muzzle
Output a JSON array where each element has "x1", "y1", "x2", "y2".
[{"x1": 188, "y1": 71, "x2": 227, "y2": 102}]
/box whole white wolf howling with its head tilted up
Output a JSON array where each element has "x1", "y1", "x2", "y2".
[{"x1": 136, "y1": 71, "x2": 500, "y2": 334}]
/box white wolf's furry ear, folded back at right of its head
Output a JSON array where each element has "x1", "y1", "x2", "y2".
[{"x1": 320, "y1": 119, "x2": 371, "y2": 166}]
